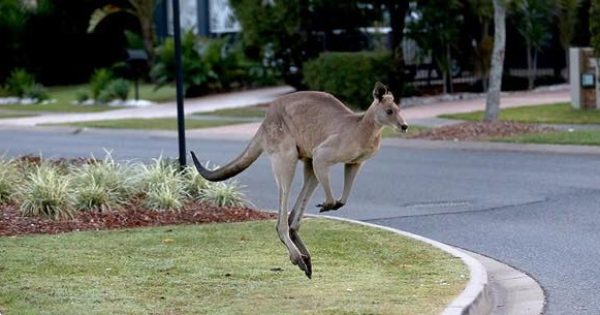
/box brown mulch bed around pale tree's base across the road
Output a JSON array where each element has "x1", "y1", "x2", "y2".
[{"x1": 408, "y1": 121, "x2": 556, "y2": 141}]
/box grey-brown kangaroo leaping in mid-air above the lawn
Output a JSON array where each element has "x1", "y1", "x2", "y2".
[{"x1": 191, "y1": 82, "x2": 408, "y2": 279}]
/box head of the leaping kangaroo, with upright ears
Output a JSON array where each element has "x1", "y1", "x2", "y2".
[{"x1": 369, "y1": 82, "x2": 408, "y2": 132}]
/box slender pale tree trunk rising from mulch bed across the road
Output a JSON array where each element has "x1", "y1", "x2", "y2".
[{"x1": 484, "y1": 0, "x2": 506, "y2": 122}]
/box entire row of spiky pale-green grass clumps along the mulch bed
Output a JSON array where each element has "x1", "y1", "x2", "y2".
[{"x1": 0, "y1": 154, "x2": 247, "y2": 219}]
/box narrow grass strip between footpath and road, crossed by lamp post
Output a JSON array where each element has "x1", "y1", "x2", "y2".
[{"x1": 64, "y1": 118, "x2": 252, "y2": 130}]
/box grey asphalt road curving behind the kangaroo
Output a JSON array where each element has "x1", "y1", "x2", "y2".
[{"x1": 0, "y1": 129, "x2": 600, "y2": 315}]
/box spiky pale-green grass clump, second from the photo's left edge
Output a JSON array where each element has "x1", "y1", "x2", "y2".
[{"x1": 17, "y1": 163, "x2": 75, "y2": 219}]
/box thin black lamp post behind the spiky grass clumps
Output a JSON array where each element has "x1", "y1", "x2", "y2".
[{"x1": 173, "y1": 0, "x2": 187, "y2": 169}]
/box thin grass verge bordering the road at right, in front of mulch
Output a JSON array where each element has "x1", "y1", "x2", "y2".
[{"x1": 492, "y1": 130, "x2": 600, "y2": 145}]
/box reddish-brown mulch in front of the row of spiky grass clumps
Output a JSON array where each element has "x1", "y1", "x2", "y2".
[{"x1": 0, "y1": 202, "x2": 275, "y2": 236}]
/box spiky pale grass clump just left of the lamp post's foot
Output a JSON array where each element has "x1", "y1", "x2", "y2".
[{"x1": 139, "y1": 157, "x2": 189, "y2": 211}]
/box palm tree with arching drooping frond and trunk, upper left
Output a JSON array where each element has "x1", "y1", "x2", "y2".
[{"x1": 88, "y1": 0, "x2": 156, "y2": 65}]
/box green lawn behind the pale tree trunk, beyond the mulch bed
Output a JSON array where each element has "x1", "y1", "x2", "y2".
[{"x1": 440, "y1": 103, "x2": 600, "y2": 124}]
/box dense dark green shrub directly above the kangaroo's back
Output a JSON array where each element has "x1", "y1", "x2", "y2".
[{"x1": 303, "y1": 52, "x2": 392, "y2": 109}]
